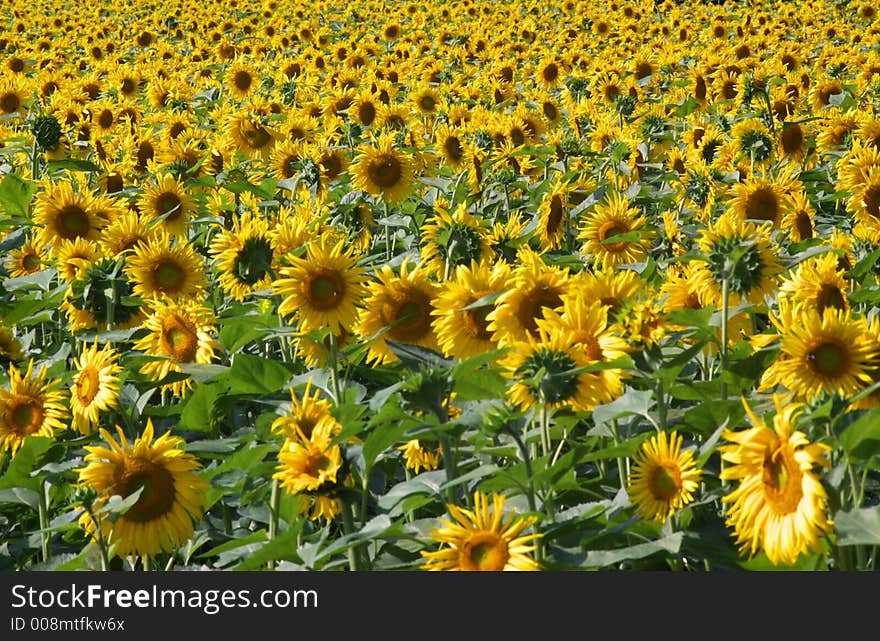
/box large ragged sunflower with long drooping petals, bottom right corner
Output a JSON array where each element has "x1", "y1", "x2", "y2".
[{"x1": 719, "y1": 395, "x2": 833, "y2": 565}]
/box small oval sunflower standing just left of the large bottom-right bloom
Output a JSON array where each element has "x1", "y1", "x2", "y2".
[{"x1": 628, "y1": 431, "x2": 702, "y2": 523}]
